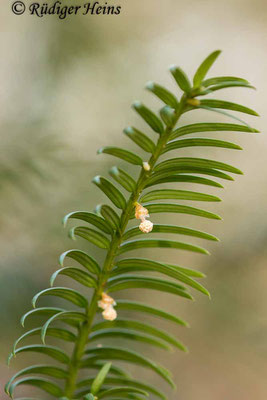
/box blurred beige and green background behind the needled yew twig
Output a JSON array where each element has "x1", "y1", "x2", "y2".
[{"x1": 0, "y1": 0, "x2": 267, "y2": 400}]
